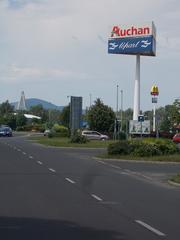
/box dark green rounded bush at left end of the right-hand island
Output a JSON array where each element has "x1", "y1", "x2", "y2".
[{"x1": 108, "y1": 141, "x2": 131, "y2": 155}]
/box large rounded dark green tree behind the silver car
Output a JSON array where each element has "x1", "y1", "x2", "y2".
[{"x1": 88, "y1": 98, "x2": 115, "y2": 132}]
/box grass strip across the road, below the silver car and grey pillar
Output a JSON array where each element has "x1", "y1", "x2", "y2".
[{"x1": 30, "y1": 136, "x2": 113, "y2": 148}]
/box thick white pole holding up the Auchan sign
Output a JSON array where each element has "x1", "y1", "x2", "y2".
[{"x1": 133, "y1": 55, "x2": 140, "y2": 120}]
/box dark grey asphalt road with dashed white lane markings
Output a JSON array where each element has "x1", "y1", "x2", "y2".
[{"x1": 0, "y1": 133, "x2": 180, "y2": 240}]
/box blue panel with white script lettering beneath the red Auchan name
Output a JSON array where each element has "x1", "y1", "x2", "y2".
[{"x1": 108, "y1": 35, "x2": 156, "y2": 56}]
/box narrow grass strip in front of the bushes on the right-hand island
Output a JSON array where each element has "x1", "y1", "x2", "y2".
[{"x1": 98, "y1": 154, "x2": 180, "y2": 162}]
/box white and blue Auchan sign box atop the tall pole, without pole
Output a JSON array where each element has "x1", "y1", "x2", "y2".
[{"x1": 108, "y1": 22, "x2": 156, "y2": 56}]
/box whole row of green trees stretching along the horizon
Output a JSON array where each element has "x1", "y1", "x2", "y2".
[{"x1": 0, "y1": 98, "x2": 180, "y2": 134}]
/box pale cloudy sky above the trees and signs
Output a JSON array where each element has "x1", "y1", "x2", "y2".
[{"x1": 0, "y1": 0, "x2": 180, "y2": 111}]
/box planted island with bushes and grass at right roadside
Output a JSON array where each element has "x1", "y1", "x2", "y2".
[{"x1": 102, "y1": 138, "x2": 180, "y2": 162}]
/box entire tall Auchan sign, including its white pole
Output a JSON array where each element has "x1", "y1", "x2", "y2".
[{"x1": 108, "y1": 22, "x2": 156, "y2": 121}]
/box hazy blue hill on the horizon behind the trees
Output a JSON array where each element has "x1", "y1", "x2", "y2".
[{"x1": 11, "y1": 98, "x2": 64, "y2": 111}]
